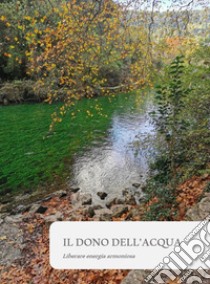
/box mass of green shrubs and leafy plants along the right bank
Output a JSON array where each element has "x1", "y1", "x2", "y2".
[{"x1": 145, "y1": 51, "x2": 210, "y2": 220}]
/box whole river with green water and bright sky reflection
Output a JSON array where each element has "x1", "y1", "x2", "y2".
[{"x1": 0, "y1": 93, "x2": 156, "y2": 198}]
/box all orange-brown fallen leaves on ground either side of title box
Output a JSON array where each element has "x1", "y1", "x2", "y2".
[{"x1": 0, "y1": 175, "x2": 210, "y2": 284}]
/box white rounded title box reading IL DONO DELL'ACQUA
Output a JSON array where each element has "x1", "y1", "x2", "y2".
[{"x1": 50, "y1": 222, "x2": 210, "y2": 269}]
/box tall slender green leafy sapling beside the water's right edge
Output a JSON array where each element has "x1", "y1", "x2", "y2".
[{"x1": 156, "y1": 56, "x2": 191, "y2": 190}]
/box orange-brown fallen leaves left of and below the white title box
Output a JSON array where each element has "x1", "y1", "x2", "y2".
[{"x1": 0, "y1": 192, "x2": 128, "y2": 284}]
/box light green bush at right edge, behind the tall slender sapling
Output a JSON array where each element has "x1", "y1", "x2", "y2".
[{"x1": 177, "y1": 43, "x2": 210, "y2": 178}]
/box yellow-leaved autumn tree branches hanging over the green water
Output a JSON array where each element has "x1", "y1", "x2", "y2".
[{"x1": 20, "y1": 0, "x2": 150, "y2": 126}]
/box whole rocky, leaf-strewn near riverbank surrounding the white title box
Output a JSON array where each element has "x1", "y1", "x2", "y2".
[{"x1": 0, "y1": 176, "x2": 210, "y2": 284}]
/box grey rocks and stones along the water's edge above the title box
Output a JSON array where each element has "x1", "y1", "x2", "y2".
[{"x1": 0, "y1": 184, "x2": 144, "y2": 265}]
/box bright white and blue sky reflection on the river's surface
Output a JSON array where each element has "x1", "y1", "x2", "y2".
[{"x1": 70, "y1": 97, "x2": 155, "y2": 200}]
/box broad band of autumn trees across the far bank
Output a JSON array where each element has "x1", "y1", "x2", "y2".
[{"x1": 0, "y1": 0, "x2": 208, "y2": 104}]
